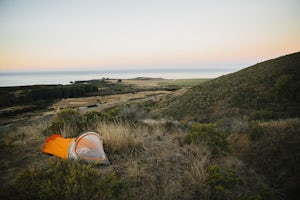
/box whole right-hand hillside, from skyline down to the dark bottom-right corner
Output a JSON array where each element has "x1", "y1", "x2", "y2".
[{"x1": 153, "y1": 52, "x2": 300, "y2": 199}]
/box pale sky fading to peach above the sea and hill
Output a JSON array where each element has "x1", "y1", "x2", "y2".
[{"x1": 0, "y1": 0, "x2": 300, "y2": 71}]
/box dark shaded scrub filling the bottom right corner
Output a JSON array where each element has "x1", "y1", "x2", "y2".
[{"x1": 243, "y1": 119, "x2": 300, "y2": 199}]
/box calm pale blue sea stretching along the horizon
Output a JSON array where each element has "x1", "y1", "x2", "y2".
[{"x1": 0, "y1": 69, "x2": 237, "y2": 87}]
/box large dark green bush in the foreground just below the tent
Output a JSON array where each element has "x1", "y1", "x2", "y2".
[{"x1": 1, "y1": 159, "x2": 129, "y2": 200}]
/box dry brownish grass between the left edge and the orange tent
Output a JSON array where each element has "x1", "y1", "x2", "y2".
[{"x1": 0, "y1": 120, "x2": 47, "y2": 188}]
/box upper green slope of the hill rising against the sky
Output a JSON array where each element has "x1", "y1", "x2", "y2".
[{"x1": 162, "y1": 52, "x2": 300, "y2": 122}]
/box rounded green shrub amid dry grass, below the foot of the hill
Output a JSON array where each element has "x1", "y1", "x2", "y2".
[{"x1": 185, "y1": 124, "x2": 229, "y2": 153}]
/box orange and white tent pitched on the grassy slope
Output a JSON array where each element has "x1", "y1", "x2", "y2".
[{"x1": 42, "y1": 132, "x2": 109, "y2": 164}]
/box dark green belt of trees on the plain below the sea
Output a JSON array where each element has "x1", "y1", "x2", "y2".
[{"x1": 0, "y1": 80, "x2": 138, "y2": 107}]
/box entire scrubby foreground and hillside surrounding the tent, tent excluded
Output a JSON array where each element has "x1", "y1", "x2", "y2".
[{"x1": 0, "y1": 53, "x2": 300, "y2": 200}]
